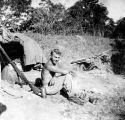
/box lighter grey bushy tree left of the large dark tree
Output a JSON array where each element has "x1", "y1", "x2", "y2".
[{"x1": 21, "y1": 0, "x2": 65, "y2": 34}]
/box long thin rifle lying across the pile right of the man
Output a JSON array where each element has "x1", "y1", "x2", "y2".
[{"x1": 71, "y1": 49, "x2": 112, "y2": 64}]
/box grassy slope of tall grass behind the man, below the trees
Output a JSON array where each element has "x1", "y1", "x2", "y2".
[{"x1": 26, "y1": 33, "x2": 110, "y2": 62}]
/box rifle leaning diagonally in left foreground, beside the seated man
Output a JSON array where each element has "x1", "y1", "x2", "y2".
[{"x1": 0, "y1": 45, "x2": 42, "y2": 97}]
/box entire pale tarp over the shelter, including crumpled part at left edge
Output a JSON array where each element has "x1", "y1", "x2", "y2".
[{"x1": 0, "y1": 27, "x2": 47, "y2": 65}]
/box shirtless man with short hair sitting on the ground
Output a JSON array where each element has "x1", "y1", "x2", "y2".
[{"x1": 41, "y1": 49, "x2": 71, "y2": 98}]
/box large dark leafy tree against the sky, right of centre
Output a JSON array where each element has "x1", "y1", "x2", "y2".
[{"x1": 66, "y1": 0, "x2": 112, "y2": 36}]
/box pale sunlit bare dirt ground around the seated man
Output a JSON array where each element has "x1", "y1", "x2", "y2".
[{"x1": 0, "y1": 70, "x2": 125, "y2": 120}]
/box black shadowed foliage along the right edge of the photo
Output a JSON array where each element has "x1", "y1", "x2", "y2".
[{"x1": 112, "y1": 18, "x2": 125, "y2": 74}]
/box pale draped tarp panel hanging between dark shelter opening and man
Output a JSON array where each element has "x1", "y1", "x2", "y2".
[{"x1": 13, "y1": 33, "x2": 47, "y2": 65}]
